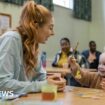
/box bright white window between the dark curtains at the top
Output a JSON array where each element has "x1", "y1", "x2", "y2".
[{"x1": 53, "y1": 0, "x2": 73, "y2": 9}]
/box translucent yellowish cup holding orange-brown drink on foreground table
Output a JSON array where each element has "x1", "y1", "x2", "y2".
[{"x1": 41, "y1": 84, "x2": 57, "y2": 101}]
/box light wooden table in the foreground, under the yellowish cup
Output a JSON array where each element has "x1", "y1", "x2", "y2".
[{"x1": 13, "y1": 87, "x2": 105, "y2": 105}]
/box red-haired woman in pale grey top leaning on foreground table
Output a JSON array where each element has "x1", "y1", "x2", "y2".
[{"x1": 0, "y1": 0, "x2": 65, "y2": 93}]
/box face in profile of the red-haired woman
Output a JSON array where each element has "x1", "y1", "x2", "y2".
[{"x1": 37, "y1": 18, "x2": 54, "y2": 43}]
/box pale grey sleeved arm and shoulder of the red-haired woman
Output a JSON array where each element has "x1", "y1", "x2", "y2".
[{"x1": 0, "y1": 33, "x2": 47, "y2": 93}]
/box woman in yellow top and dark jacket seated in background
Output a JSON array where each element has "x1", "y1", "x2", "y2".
[{"x1": 52, "y1": 38, "x2": 73, "y2": 67}]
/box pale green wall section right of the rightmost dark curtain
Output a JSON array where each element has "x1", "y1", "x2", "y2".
[{"x1": 89, "y1": 0, "x2": 105, "y2": 51}]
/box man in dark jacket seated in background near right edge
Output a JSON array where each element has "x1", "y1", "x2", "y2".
[{"x1": 82, "y1": 41, "x2": 101, "y2": 69}]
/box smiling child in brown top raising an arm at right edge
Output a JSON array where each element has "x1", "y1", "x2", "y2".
[{"x1": 68, "y1": 52, "x2": 105, "y2": 90}]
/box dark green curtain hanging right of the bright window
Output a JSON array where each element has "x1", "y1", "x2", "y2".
[{"x1": 73, "y1": 0, "x2": 91, "y2": 21}]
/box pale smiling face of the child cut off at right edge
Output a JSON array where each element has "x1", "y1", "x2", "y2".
[{"x1": 98, "y1": 53, "x2": 105, "y2": 76}]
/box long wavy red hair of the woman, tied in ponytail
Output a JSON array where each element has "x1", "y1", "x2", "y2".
[{"x1": 17, "y1": 0, "x2": 52, "y2": 76}]
